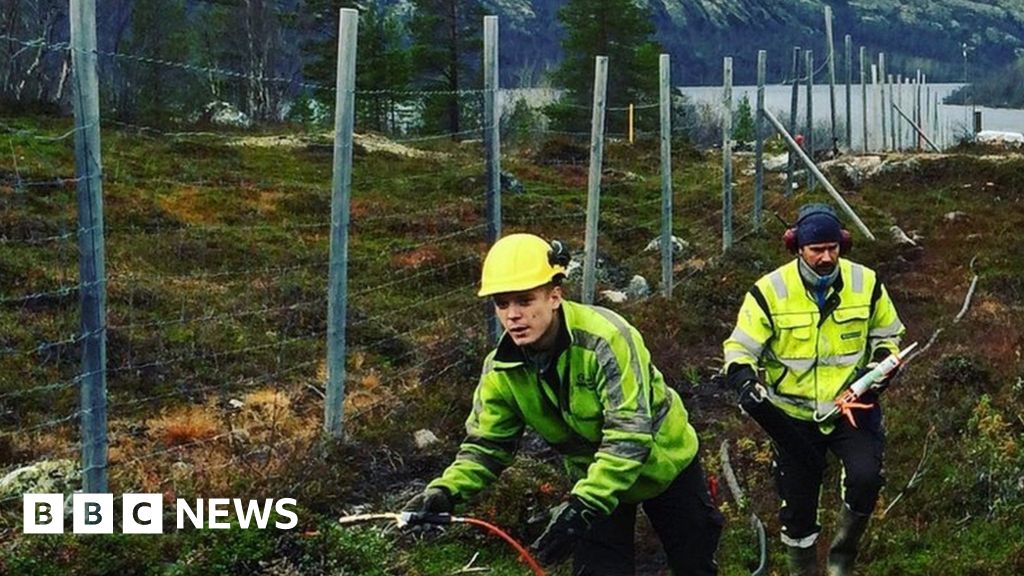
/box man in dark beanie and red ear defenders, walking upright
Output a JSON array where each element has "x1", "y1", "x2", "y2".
[{"x1": 723, "y1": 204, "x2": 904, "y2": 576}]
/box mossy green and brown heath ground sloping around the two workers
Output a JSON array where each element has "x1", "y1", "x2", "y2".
[{"x1": 0, "y1": 118, "x2": 1024, "y2": 575}]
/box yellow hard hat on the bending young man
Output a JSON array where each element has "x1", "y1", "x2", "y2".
[{"x1": 477, "y1": 234, "x2": 568, "y2": 296}]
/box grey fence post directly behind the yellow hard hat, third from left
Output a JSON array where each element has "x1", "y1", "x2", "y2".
[{"x1": 483, "y1": 16, "x2": 502, "y2": 344}]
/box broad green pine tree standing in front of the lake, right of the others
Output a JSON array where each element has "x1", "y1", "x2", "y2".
[{"x1": 545, "y1": 0, "x2": 659, "y2": 132}]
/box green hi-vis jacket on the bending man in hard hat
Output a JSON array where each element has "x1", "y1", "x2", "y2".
[{"x1": 430, "y1": 301, "x2": 697, "y2": 513}]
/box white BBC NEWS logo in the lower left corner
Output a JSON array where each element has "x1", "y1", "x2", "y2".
[{"x1": 23, "y1": 494, "x2": 299, "y2": 534}]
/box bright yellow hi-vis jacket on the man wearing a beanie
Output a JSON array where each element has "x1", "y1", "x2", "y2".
[{"x1": 724, "y1": 258, "x2": 904, "y2": 424}]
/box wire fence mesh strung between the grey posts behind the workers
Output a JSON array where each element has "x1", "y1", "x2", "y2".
[{"x1": 0, "y1": 13, "x2": 839, "y2": 532}]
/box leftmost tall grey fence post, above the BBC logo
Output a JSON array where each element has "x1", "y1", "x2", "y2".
[{"x1": 71, "y1": 0, "x2": 108, "y2": 493}]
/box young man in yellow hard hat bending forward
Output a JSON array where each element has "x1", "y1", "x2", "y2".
[{"x1": 406, "y1": 234, "x2": 722, "y2": 576}]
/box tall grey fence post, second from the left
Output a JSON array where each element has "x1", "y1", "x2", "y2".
[{"x1": 324, "y1": 8, "x2": 359, "y2": 439}]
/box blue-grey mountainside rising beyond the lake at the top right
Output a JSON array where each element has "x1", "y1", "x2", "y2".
[{"x1": 488, "y1": 0, "x2": 1024, "y2": 85}]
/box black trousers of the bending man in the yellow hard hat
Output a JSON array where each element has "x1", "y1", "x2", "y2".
[{"x1": 572, "y1": 458, "x2": 724, "y2": 576}]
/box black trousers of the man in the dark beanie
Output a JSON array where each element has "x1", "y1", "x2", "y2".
[{"x1": 773, "y1": 402, "x2": 886, "y2": 547}]
